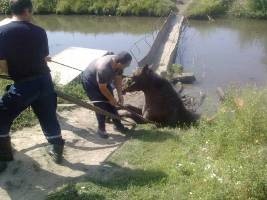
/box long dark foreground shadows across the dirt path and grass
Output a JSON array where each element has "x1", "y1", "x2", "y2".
[{"x1": 0, "y1": 151, "x2": 167, "y2": 200}]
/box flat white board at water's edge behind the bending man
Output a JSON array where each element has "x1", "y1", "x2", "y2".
[{"x1": 48, "y1": 47, "x2": 108, "y2": 85}]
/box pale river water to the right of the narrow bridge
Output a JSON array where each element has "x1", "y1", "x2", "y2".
[{"x1": 177, "y1": 19, "x2": 267, "y2": 92}]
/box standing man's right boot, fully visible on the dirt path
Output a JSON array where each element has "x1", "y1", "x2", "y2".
[{"x1": 47, "y1": 140, "x2": 65, "y2": 164}]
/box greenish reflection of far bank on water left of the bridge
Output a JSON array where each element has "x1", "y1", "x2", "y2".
[{"x1": 34, "y1": 15, "x2": 159, "y2": 35}]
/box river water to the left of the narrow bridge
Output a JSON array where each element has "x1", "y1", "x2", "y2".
[{"x1": 0, "y1": 15, "x2": 163, "y2": 73}]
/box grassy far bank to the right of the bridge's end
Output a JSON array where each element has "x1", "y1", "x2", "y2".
[{"x1": 187, "y1": 0, "x2": 267, "y2": 19}]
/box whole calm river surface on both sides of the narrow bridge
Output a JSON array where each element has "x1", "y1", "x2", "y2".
[{"x1": 0, "y1": 15, "x2": 267, "y2": 92}]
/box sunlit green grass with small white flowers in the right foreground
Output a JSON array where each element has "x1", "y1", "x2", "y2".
[{"x1": 48, "y1": 90, "x2": 267, "y2": 200}]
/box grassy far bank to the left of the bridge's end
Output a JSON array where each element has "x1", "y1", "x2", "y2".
[{"x1": 0, "y1": 0, "x2": 176, "y2": 16}]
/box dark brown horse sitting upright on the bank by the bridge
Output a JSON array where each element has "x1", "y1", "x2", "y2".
[{"x1": 123, "y1": 66, "x2": 199, "y2": 126}]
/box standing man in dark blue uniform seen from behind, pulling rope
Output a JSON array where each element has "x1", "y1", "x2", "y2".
[{"x1": 0, "y1": 0, "x2": 64, "y2": 172}]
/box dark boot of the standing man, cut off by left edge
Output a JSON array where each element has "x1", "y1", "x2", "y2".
[{"x1": 0, "y1": 137, "x2": 14, "y2": 173}]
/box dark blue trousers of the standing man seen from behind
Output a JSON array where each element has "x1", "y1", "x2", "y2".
[{"x1": 0, "y1": 74, "x2": 63, "y2": 144}]
